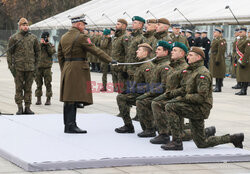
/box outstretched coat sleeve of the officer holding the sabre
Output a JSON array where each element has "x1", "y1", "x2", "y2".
[{"x1": 79, "y1": 35, "x2": 112, "y2": 63}]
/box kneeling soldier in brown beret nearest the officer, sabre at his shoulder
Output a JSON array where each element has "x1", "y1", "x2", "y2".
[{"x1": 115, "y1": 43, "x2": 153, "y2": 133}]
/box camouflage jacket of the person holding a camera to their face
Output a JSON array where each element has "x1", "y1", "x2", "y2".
[{"x1": 37, "y1": 43, "x2": 56, "y2": 68}]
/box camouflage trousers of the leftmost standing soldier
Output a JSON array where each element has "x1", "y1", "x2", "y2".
[{"x1": 15, "y1": 70, "x2": 34, "y2": 107}]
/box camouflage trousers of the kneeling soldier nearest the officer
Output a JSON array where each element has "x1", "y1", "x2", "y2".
[{"x1": 116, "y1": 93, "x2": 141, "y2": 125}]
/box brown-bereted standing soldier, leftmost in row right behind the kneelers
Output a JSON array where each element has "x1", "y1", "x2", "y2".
[{"x1": 111, "y1": 19, "x2": 128, "y2": 92}]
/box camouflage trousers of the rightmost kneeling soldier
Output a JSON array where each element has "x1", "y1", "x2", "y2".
[{"x1": 165, "y1": 102, "x2": 230, "y2": 148}]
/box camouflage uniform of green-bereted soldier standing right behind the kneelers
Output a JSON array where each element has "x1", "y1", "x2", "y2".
[{"x1": 124, "y1": 30, "x2": 145, "y2": 77}]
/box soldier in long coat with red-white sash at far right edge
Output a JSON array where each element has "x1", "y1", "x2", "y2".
[{"x1": 235, "y1": 27, "x2": 250, "y2": 95}]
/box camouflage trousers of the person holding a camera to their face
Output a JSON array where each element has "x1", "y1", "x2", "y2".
[{"x1": 35, "y1": 68, "x2": 52, "y2": 97}]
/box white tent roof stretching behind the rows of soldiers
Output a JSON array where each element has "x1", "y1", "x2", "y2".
[{"x1": 31, "y1": 0, "x2": 250, "y2": 30}]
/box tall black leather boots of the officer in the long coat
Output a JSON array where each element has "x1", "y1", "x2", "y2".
[{"x1": 63, "y1": 103, "x2": 87, "y2": 134}]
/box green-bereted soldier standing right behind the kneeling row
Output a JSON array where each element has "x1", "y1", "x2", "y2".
[{"x1": 124, "y1": 16, "x2": 145, "y2": 81}]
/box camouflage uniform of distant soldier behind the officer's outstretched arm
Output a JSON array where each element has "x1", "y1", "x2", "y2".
[{"x1": 100, "y1": 37, "x2": 112, "y2": 89}]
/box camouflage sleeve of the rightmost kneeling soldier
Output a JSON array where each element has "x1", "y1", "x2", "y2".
[{"x1": 184, "y1": 74, "x2": 212, "y2": 103}]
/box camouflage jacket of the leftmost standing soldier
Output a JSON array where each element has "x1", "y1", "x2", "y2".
[{"x1": 7, "y1": 31, "x2": 40, "y2": 71}]
